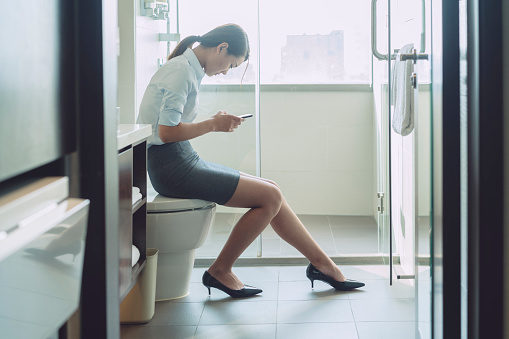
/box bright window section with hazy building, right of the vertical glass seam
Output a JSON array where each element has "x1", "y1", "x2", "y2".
[{"x1": 260, "y1": 0, "x2": 371, "y2": 84}]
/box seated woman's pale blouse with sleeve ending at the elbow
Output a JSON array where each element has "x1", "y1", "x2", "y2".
[{"x1": 136, "y1": 48, "x2": 205, "y2": 147}]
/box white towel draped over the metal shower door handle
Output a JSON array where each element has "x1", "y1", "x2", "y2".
[{"x1": 391, "y1": 44, "x2": 415, "y2": 136}]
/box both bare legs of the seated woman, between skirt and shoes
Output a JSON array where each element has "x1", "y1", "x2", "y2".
[{"x1": 208, "y1": 173, "x2": 345, "y2": 289}]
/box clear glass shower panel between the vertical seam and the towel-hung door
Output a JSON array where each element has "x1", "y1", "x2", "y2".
[{"x1": 260, "y1": 0, "x2": 378, "y2": 257}]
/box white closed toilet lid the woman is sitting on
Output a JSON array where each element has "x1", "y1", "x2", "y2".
[{"x1": 147, "y1": 187, "x2": 215, "y2": 213}]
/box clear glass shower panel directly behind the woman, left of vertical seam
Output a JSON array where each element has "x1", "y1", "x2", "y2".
[{"x1": 179, "y1": 0, "x2": 258, "y2": 258}]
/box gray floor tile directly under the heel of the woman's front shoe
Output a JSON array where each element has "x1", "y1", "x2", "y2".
[{"x1": 278, "y1": 280, "x2": 350, "y2": 300}]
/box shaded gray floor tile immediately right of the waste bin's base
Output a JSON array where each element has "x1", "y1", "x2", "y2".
[{"x1": 147, "y1": 301, "x2": 205, "y2": 326}]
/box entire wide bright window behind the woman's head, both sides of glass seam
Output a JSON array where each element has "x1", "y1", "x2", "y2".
[{"x1": 179, "y1": 0, "x2": 371, "y2": 84}]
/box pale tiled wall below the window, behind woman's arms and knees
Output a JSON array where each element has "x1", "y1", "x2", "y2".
[{"x1": 192, "y1": 86, "x2": 374, "y2": 215}]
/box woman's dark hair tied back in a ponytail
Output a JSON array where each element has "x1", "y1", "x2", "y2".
[{"x1": 168, "y1": 24, "x2": 249, "y2": 61}]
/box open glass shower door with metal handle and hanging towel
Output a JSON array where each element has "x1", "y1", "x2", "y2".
[{"x1": 389, "y1": 0, "x2": 432, "y2": 339}]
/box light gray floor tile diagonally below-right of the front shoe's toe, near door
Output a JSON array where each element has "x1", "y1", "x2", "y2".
[{"x1": 350, "y1": 298, "x2": 415, "y2": 323}]
